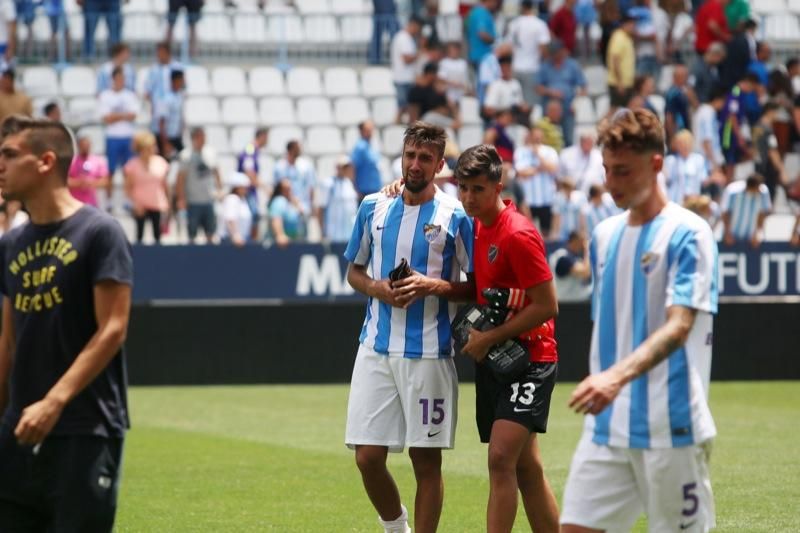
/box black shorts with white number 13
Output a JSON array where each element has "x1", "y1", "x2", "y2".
[{"x1": 475, "y1": 363, "x2": 558, "y2": 442}]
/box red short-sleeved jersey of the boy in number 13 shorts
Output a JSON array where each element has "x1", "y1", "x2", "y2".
[{"x1": 473, "y1": 200, "x2": 558, "y2": 362}]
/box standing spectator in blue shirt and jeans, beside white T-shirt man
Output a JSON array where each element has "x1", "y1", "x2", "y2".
[{"x1": 536, "y1": 39, "x2": 586, "y2": 146}]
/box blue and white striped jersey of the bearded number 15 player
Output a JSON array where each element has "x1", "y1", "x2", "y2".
[{"x1": 344, "y1": 188, "x2": 474, "y2": 359}]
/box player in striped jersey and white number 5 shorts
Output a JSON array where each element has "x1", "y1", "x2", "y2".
[{"x1": 561, "y1": 108, "x2": 717, "y2": 533}]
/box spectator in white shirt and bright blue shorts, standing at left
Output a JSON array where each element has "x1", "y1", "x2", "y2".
[{"x1": 98, "y1": 67, "x2": 140, "y2": 198}]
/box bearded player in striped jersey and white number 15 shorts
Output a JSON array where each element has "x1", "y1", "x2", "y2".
[{"x1": 345, "y1": 122, "x2": 475, "y2": 533}]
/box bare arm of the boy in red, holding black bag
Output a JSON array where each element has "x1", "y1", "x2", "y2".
[{"x1": 461, "y1": 280, "x2": 558, "y2": 361}]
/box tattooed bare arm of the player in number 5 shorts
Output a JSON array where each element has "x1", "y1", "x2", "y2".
[{"x1": 569, "y1": 305, "x2": 697, "y2": 415}]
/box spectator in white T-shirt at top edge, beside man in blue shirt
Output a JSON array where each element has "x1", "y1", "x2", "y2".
[{"x1": 506, "y1": 0, "x2": 550, "y2": 105}]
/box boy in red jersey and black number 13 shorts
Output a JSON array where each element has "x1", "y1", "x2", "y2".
[{"x1": 455, "y1": 145, "x2": 559, "y2": 532}]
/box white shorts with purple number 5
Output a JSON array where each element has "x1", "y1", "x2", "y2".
[{"x1": 561, "y1": 434, "x2": 716, "y2": 533}]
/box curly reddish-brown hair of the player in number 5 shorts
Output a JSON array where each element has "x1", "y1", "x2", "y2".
[{"x1": 597, "y1": 107, "x2": 664, "y2": 154}]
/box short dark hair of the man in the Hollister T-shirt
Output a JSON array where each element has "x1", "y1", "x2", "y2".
[{"x1": 0, "y1": 115, "x2": 75, "y2": 183}]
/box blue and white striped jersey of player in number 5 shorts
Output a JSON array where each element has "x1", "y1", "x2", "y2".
[{"x1": 585, "y1": 202, "x2": 717, "y2": 448}]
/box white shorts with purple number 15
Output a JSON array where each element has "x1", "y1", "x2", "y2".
[{"x1": 345, "y1": 345, "x2": 458, "y2": 452}]
